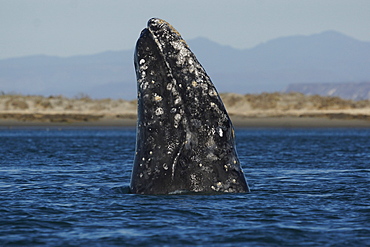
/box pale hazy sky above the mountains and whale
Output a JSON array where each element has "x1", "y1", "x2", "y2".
[{"x1": 0, "y1": 0, "x2": 370, "y2": 59}]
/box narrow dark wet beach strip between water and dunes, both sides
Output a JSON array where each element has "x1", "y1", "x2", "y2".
[{"x1": 0, "y1": 116, "x2": 370, "y2": 129}]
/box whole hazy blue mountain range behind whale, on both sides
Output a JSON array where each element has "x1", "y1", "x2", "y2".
[{"x1": 0, "y1": 31, "x2": 370, "y2": 99}]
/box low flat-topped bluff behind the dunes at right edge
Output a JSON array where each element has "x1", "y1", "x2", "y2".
[{"x1": 285, "y1": 82, "x2": 370, "y2": 100}]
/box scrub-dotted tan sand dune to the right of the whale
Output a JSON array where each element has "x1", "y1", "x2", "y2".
[{"x1": 221, "y1": 93, "x2": 370, "y2": 118}]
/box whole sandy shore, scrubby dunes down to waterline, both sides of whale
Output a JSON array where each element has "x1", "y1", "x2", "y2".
[{"x1": 0, "y1": 93, "x2": 370, "y2": 128}]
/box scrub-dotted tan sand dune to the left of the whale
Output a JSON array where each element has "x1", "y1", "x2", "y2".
[{"x1": 0, "y1": 95, "x2": 136, "y2": 122}]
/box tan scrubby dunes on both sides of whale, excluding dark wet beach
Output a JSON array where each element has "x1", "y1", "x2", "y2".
[{"x1": 0, "y1": 93, "x2": 370, "y2": 127}]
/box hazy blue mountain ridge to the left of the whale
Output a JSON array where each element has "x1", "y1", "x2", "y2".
[{"x1": 0, "y1": 51, "x2": 136, "y2": 99}]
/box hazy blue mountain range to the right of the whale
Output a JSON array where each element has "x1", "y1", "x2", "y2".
[{"x1": 189, "y1": 31, "x2": 370, "y2": 93}]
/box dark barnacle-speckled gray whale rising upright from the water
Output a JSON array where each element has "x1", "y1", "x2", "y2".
[{"x1": 130, "y1": 18, "x2": 249, "y2": 194}]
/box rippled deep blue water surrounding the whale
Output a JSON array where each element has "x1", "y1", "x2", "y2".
[{"x1": 0, "y1": 128, "x2": 370, "y2": 246}]
